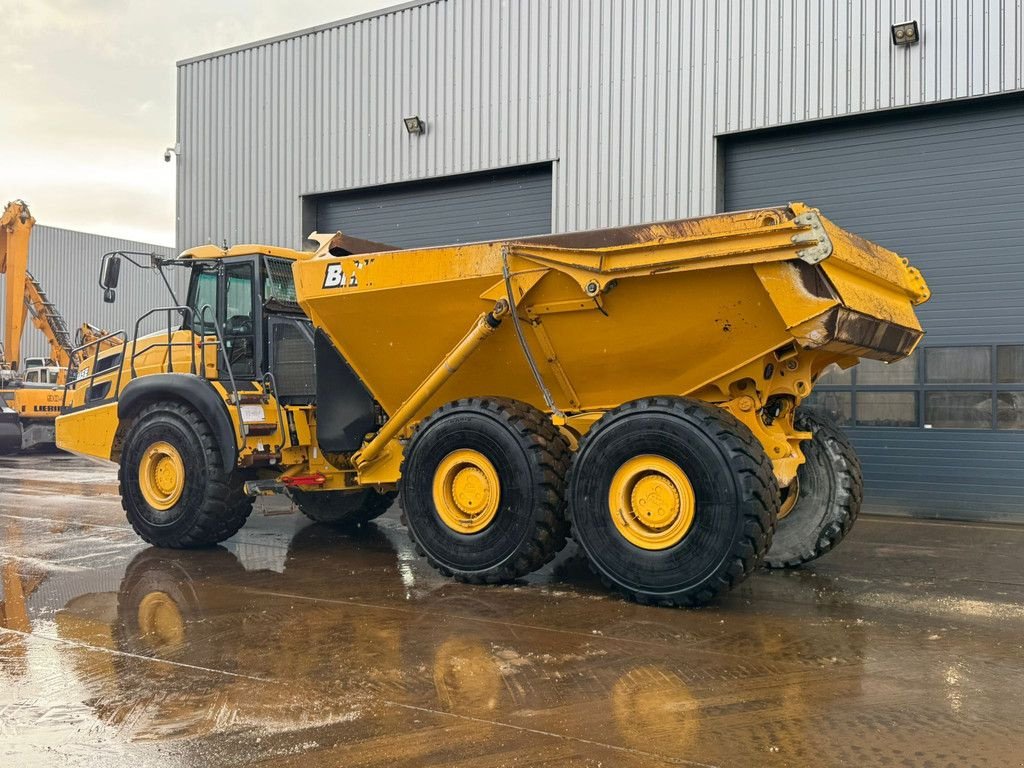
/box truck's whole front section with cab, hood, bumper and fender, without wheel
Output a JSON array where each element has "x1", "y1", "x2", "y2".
[{"x1": 57, "y1": 245, "x2": 349, "y2": 489}]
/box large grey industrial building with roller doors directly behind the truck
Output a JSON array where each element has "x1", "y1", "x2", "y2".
[{"x1": 176, "y1": 0, "x2": 1024, "y2": 519}]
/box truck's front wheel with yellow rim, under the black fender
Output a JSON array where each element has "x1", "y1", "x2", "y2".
[{"x1": 118, "y1": 400, "x2": 253, "y2": 549}]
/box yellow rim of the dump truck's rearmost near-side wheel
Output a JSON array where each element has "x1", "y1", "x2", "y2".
[{"x1": 608, "y1": 454, "x2": 696, "y2": 550}]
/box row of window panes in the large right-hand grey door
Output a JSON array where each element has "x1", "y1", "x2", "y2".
[{"x1": 807, "y1": 344, "x2": 1024, "y2": 430}]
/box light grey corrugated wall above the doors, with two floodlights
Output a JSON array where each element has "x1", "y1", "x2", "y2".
[{"x1": 177, "y1": 0, "x2": 1024, "y2": 246}]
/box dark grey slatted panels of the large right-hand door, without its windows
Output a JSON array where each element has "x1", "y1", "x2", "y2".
[{"x1": 724, "y1": 98, "x2": 1024, "y2": 519}]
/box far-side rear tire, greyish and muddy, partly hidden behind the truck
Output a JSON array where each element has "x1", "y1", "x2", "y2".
[{"x1": 765, "y1": 410, "x2": 863, "y2": 568}]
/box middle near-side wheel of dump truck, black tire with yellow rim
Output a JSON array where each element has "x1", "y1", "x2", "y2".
[{"x1": 398, "y1": 397, "x2": 569, "y2": 584}]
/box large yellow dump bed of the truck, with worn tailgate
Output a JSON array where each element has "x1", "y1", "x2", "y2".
[{"x1": 295, "y1": 204, "x2": 928, "y2": 428}]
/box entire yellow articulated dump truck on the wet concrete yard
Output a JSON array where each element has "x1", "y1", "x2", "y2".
[{"x1": 57, "y1": 203, "x2": 929, "y2": 605}]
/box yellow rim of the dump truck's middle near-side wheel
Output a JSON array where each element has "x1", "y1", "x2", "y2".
[{"x1": 433, "y1": 449, "x2": 502, "y2": 534}]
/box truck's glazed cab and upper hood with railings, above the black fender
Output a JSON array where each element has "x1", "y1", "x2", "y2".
[{"x1": 65, "y1": 245, "x2": 314, "y2": 409}]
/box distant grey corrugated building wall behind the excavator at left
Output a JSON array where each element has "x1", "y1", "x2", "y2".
[{"x1": 0, "y1": 224, "x2": 179, "y2": 359}]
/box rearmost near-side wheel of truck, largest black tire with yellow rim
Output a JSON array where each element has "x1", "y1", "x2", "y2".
[{"x1": 568, "y1": 397, "x2": 779, "y2": 606}]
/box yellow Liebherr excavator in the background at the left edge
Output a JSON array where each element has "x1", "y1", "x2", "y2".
[{"x1": 0, "y1": 200, "x2": 115, "y2": 453}]
